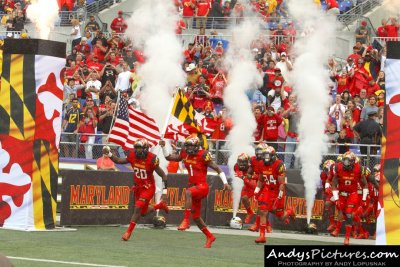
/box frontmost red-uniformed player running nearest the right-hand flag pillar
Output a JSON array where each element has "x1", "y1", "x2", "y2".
[{"x1": 332, "y1": 151, "x2": 368, "y2": 245}]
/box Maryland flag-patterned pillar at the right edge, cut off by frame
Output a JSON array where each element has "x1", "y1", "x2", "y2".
[{"x1": 376, "y1": 41, "x2": 400, "y2": 245}]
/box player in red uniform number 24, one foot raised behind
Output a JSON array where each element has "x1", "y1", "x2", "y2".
[{"x1": 254, "y1": 146, "x2": 295, "y2": 243}]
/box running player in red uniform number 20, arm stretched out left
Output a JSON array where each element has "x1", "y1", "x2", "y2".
[{"x1": 103, "y1": 139, "x2": 169, "y2": 241}]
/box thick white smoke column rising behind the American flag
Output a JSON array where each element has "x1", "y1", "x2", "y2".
[{"x1": 127, "y1": 0, "x2": 185, "y2": 203}]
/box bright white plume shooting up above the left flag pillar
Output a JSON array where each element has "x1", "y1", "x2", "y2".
[{"x1": 26, "y1": 0, "x2": 59, "y2": 40}]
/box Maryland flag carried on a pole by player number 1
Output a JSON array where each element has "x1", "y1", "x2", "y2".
[{"x1": 164, "y1": 89, "x2": 208, "y2": 149}]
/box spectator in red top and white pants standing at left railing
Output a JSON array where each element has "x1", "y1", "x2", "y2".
[{"x1": 78, "y1": 107, "x2": 97, "y2": 159}]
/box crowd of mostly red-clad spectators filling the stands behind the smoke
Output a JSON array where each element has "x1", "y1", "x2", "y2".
[{"x1": 3, "y1": 0, "x2": 399, "y2": 163}]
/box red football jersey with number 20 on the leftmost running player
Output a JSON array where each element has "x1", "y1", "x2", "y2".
[{"x1": 127, "y1": 150, "x2": 159, "y2": 185}]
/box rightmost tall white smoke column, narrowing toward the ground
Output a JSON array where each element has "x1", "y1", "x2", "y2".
[{"x1": 289, "y1": 0, "x2": 336, "y2": 223}]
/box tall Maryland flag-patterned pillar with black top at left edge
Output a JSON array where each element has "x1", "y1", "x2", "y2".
[{"x1": 0, "y1": 39, "x2": 66, "y2": 230}]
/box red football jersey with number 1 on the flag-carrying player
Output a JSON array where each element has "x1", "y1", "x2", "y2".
[{"x1": 180, "y1": 149, "x2": 212, "y2": 185}]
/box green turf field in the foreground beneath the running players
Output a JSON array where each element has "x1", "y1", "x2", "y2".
[{"x1": 0, "y1": 227, "x2": 340, "y2": 267}]
